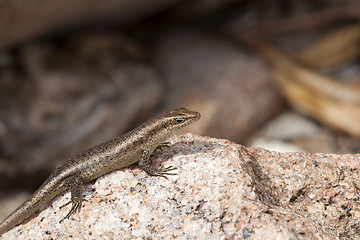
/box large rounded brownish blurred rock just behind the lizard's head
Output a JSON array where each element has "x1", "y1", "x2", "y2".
[{"x1": 154, "y1": 31, "x2": 281, "y2": 142}]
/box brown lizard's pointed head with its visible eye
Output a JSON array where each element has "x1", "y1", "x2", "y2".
[{"x1": 163, "y1": 108, "x2": 200, "y2": 132}]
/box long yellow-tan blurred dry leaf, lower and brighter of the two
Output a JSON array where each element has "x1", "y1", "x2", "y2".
[{"x1": 263, "y1": 44, "x2": 360, "y2": 136}]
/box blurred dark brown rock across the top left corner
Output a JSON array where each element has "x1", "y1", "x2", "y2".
[{"x1": 0, "y1": 0, "x2": 181, "y2": 48}]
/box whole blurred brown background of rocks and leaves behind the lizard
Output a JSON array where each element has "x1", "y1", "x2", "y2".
[{"x1": 0, "y1": 0, "x2": 360, "y2": 225}]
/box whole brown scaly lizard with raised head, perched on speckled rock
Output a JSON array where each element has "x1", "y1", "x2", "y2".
[{"x1": 0, "y1": 108, "x2": 200, "y2": 236}]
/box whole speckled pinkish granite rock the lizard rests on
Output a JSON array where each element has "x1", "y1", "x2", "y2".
[{"x1": 4, "y1": 134, "x2": 360, "y2": 239}]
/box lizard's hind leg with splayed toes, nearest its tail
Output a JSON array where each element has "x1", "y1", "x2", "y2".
[{"x1": 60, "y1": 176, "x2": 84, "y2": 223}]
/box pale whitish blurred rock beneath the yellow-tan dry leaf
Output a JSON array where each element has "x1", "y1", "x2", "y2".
[{"x1": 250, "y1": 111, "x2": 344, "y2": 153}]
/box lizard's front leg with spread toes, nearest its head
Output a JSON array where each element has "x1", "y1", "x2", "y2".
[{"x1": 139, "y1": 149, "x2": 176, "y2": 178}]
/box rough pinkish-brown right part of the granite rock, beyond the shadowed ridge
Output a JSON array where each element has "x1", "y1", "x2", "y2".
[{"x1": 251, "y1": 148, "x2": 360, "y2": 239}]
